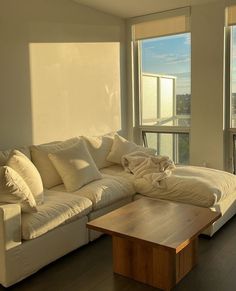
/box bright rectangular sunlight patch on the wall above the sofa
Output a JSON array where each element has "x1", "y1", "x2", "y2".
[{"x1": 29, "y1": 43, "x2": 122, "y2": 143}]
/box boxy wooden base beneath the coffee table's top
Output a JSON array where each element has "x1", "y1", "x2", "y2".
[{"x1": 113, "y1": 236, "x2": 197, "y2": 290}]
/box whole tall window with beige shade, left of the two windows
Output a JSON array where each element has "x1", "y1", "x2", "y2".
[{"x1": 134, "y1": 9, "x2": 191, "y2": 164}]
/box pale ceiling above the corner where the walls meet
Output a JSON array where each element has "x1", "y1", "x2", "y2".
[{"x1": 74, "y1": 0, "x2": 219, "y2": 18}]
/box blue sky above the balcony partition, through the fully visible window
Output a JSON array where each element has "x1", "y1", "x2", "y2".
[{"x1": 141, "y1": 33, "x2": 191, "y2": 94}]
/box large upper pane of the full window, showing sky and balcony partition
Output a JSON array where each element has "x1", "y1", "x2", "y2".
[{"x1": 139, "y1": 33, "x2": 191, "y2": 126}]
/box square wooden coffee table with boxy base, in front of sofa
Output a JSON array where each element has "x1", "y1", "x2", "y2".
[{"x1": 87, "y1": 198, "x2": 221, "y2": 290}]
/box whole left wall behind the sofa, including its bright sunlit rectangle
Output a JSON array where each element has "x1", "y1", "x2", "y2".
[{"x1": 0, "y1": 0, "x2": 126, "y2": 148}]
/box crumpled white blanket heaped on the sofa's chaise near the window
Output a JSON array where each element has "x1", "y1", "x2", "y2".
[{"x1": 121, "y1": 151, "x2": 175, "y2": 188}]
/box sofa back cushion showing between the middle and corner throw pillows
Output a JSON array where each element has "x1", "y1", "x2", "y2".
[{"x1": 83, "y1": 134, "x2": 114, "y2": 169}]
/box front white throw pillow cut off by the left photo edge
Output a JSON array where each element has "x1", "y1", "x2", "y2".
[{"x1": 0, "y1": 166, "x2": 37, "y2": 213}]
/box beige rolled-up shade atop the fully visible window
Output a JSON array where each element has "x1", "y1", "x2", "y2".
[{"x1": 133, "y1": 7, "x2": 190, "y2": 40}]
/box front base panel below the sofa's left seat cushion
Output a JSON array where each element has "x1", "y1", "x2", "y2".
[{"x1": 3, "y1": 216, "x2": 88, "y2": 291}]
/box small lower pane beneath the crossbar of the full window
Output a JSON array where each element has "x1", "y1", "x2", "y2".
[{"x1": 144, "y1": 132, "x2": 189, "y2": 164}]
